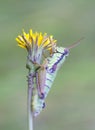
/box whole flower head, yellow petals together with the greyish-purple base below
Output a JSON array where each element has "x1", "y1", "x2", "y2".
[{"x1": 16, "y1": 29, "x2": 56, "y2": 63}]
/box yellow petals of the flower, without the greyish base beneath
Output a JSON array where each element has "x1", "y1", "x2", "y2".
[{"x1": 16, "y1": 29, "x2": 56, "y2": 53}]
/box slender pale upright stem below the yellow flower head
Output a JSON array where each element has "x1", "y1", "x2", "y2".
[{"x1": 27, "y1": 73, "x2": 33, "y2": 130}]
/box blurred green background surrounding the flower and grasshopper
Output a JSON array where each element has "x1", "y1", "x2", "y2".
[{"x1": 0, "y1": 0, "x2": 95, "y2": 130}]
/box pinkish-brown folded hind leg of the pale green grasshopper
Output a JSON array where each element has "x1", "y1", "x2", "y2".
[{"x1": 36, "y1": 59, "x2": 48, "y2": 99}]
